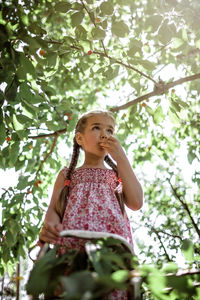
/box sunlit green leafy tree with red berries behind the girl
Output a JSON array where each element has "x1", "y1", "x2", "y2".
[{"x1": 0, "y1": 0, "x2": 200, "y2": 293}]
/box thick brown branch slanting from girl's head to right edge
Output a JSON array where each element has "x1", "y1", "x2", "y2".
[{"x1": 110, "y1": 73, "x2": 200, "y2": 112}]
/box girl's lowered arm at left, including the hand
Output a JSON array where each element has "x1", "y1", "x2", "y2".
[{"x1": 39, "y1": 171, "x2": 65, "y2": 243}]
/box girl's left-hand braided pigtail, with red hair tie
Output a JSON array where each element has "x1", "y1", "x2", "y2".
[{"x1": 55, "y1": 138, "x2": 80, "y2": 220}]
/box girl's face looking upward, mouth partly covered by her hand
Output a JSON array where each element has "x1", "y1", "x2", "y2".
[{"x1": 76, "y1": 114, "x2": 115, "y2": 157}]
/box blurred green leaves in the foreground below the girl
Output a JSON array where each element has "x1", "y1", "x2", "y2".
[{"x1": 26, "y1": 238, "x2": 200, "y2": 300}]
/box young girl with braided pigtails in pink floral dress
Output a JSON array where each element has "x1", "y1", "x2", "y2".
[{"x1": 40, "y1": 111, "x2": 143, "y2": 299}]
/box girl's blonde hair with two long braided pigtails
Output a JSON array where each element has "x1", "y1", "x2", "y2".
[{"x1": 55, "y1": 110, "x2": 125, "y2": 220}]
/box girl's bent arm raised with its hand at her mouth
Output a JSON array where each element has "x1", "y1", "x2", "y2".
[{"x1": 100, "y1": 137, "x2": 143, "y2": 210}]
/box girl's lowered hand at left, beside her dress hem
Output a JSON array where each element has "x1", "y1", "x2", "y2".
[{"x1": 39, "y1": 222, "x2": 63, "y2": 244}]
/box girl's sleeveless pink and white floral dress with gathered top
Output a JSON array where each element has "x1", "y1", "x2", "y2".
[{"x1": 60, "y1": 168, "x2": 132, "y2": 300}]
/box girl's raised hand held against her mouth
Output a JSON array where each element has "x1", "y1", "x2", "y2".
[{"x1": 100, "y1": 136, "x2": 126, "y2": 162}]
